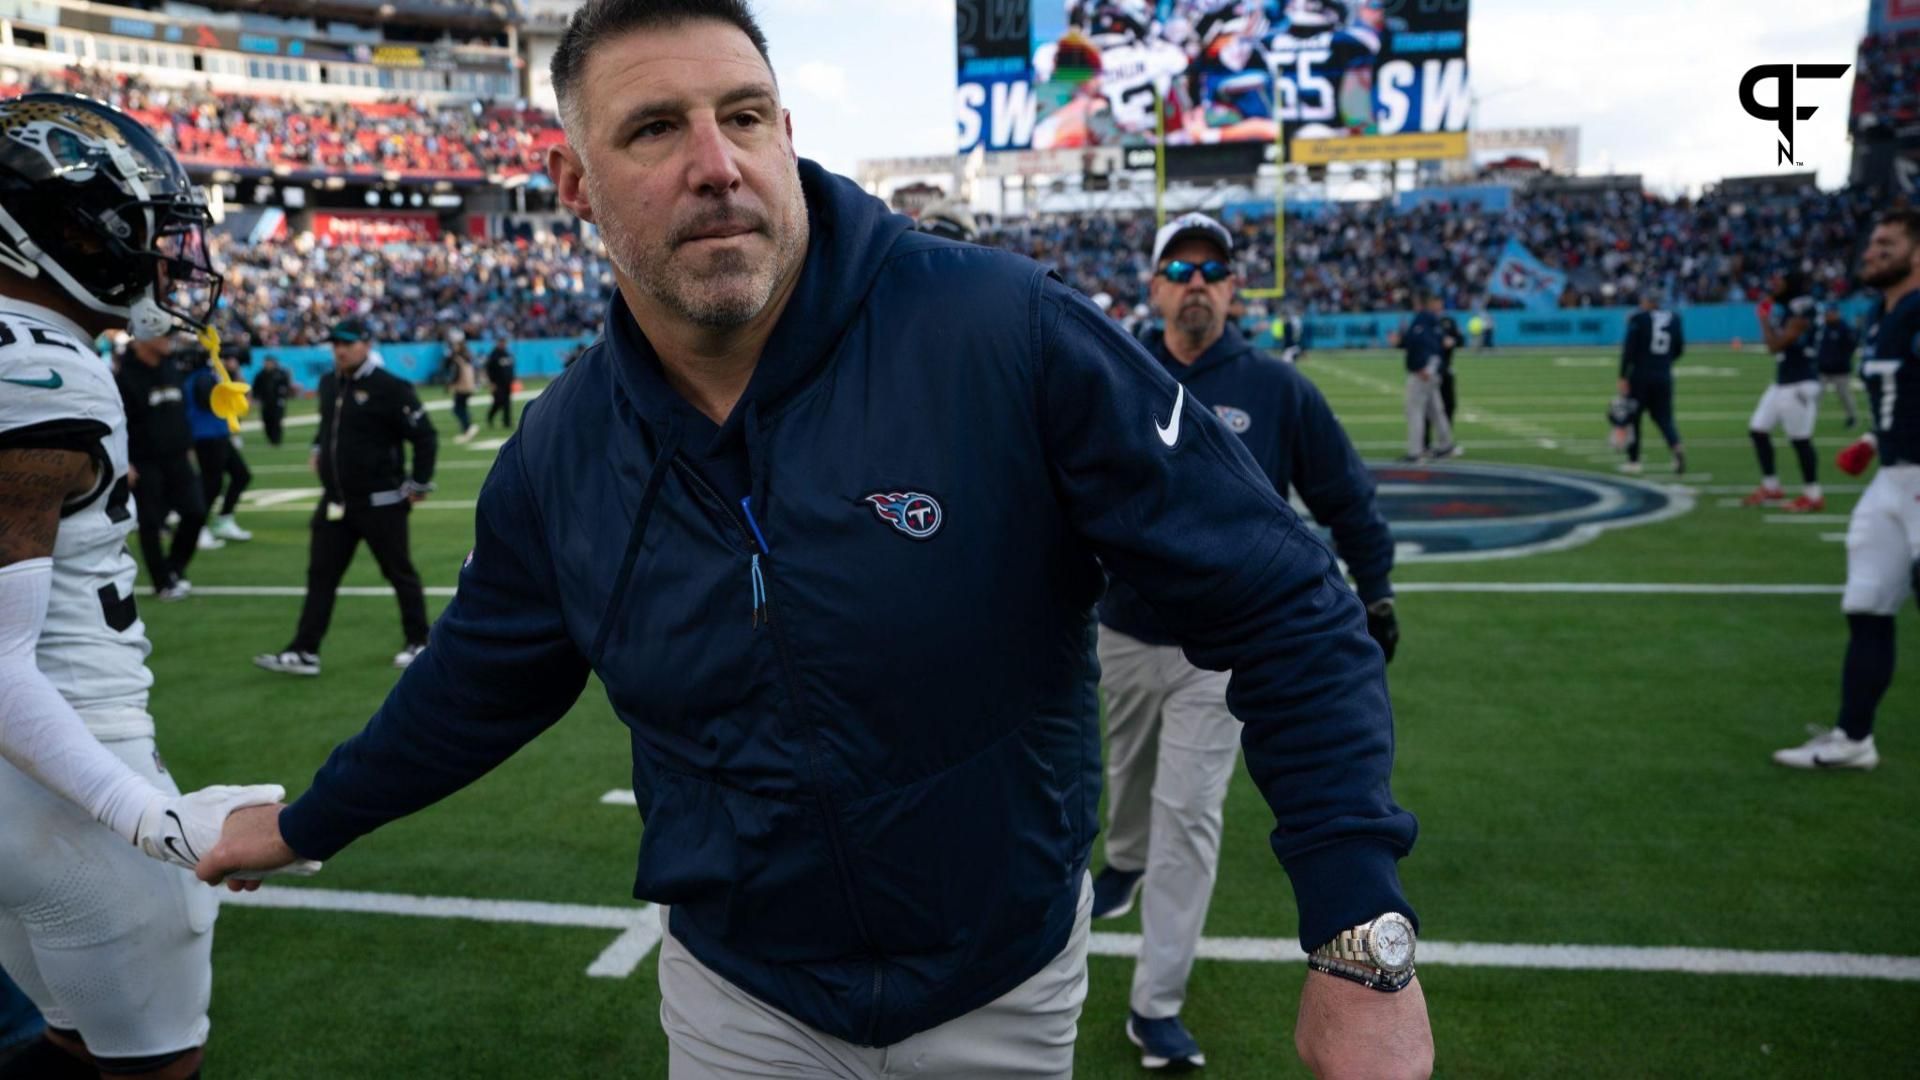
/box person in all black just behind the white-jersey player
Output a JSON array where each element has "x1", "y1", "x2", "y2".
[{"x1": 113, "y1": 338, "x2": 207, "y2": 600}]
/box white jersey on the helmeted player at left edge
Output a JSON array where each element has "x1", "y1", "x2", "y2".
[{"x1": 0, "y1": 298, "x2": 154, "y2": 740}]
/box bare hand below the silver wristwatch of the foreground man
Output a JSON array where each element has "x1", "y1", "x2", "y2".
[{"x1": 1294, "y1": 970, "x2": 1434, "y2": 1080}]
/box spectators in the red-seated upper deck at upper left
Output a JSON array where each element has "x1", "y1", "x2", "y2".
[{"x1": 24, "y1": 65, "x2": 564, "y2": 181}]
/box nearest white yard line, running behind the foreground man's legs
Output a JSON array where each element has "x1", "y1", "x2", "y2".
[{"x1": 221, "y1": 886, "x2": 1920, "y2": 982}]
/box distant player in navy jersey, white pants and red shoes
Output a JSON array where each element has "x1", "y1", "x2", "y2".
[{"x1": 1745, "y1": 269, "x2": 1826, "y2": 513}]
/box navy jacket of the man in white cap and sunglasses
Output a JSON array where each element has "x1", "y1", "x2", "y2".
[{"x1": 1100, "y1": 325, "x2": 1394, "y2": 646}]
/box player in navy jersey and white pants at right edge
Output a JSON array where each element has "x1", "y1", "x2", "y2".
[{"x1": 1774, "y1": 209, "x2": 1920, "y2": 769}]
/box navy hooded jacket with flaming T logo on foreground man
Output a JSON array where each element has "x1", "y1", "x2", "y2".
[{"x1": 280, "y1": 161, "x2": 1415, "y2": 1045}]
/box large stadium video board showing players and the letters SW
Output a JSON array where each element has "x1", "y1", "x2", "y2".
[{"x1": 956, "y1": 0, "x2": 1471, "y2": 163}]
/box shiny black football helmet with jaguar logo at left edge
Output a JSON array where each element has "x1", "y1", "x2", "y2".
[{"x1": 0, "y1": 94, "x2": 221, "y2": 338}]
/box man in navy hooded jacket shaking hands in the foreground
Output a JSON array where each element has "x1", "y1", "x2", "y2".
[{"x1": 202, "y1": 0, "x2": 1432, "y2": 1078}]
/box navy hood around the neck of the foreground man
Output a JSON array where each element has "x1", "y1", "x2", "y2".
[{"x1": 605, "y1": 160, "x2": 912, "y2": 454}]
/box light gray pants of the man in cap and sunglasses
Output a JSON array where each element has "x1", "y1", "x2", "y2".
[{"x1": 1100, "y1": 626, "x2": 1240, "y2": 1020}]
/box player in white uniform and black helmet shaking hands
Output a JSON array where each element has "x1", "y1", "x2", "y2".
[{"x1": 0, "y1": 94, "x2": 311, "y2": 1080}]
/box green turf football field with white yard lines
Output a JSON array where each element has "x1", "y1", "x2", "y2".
[{"x1": 131, "y1": 348, "x2": 1920, "y2": 1078}]
